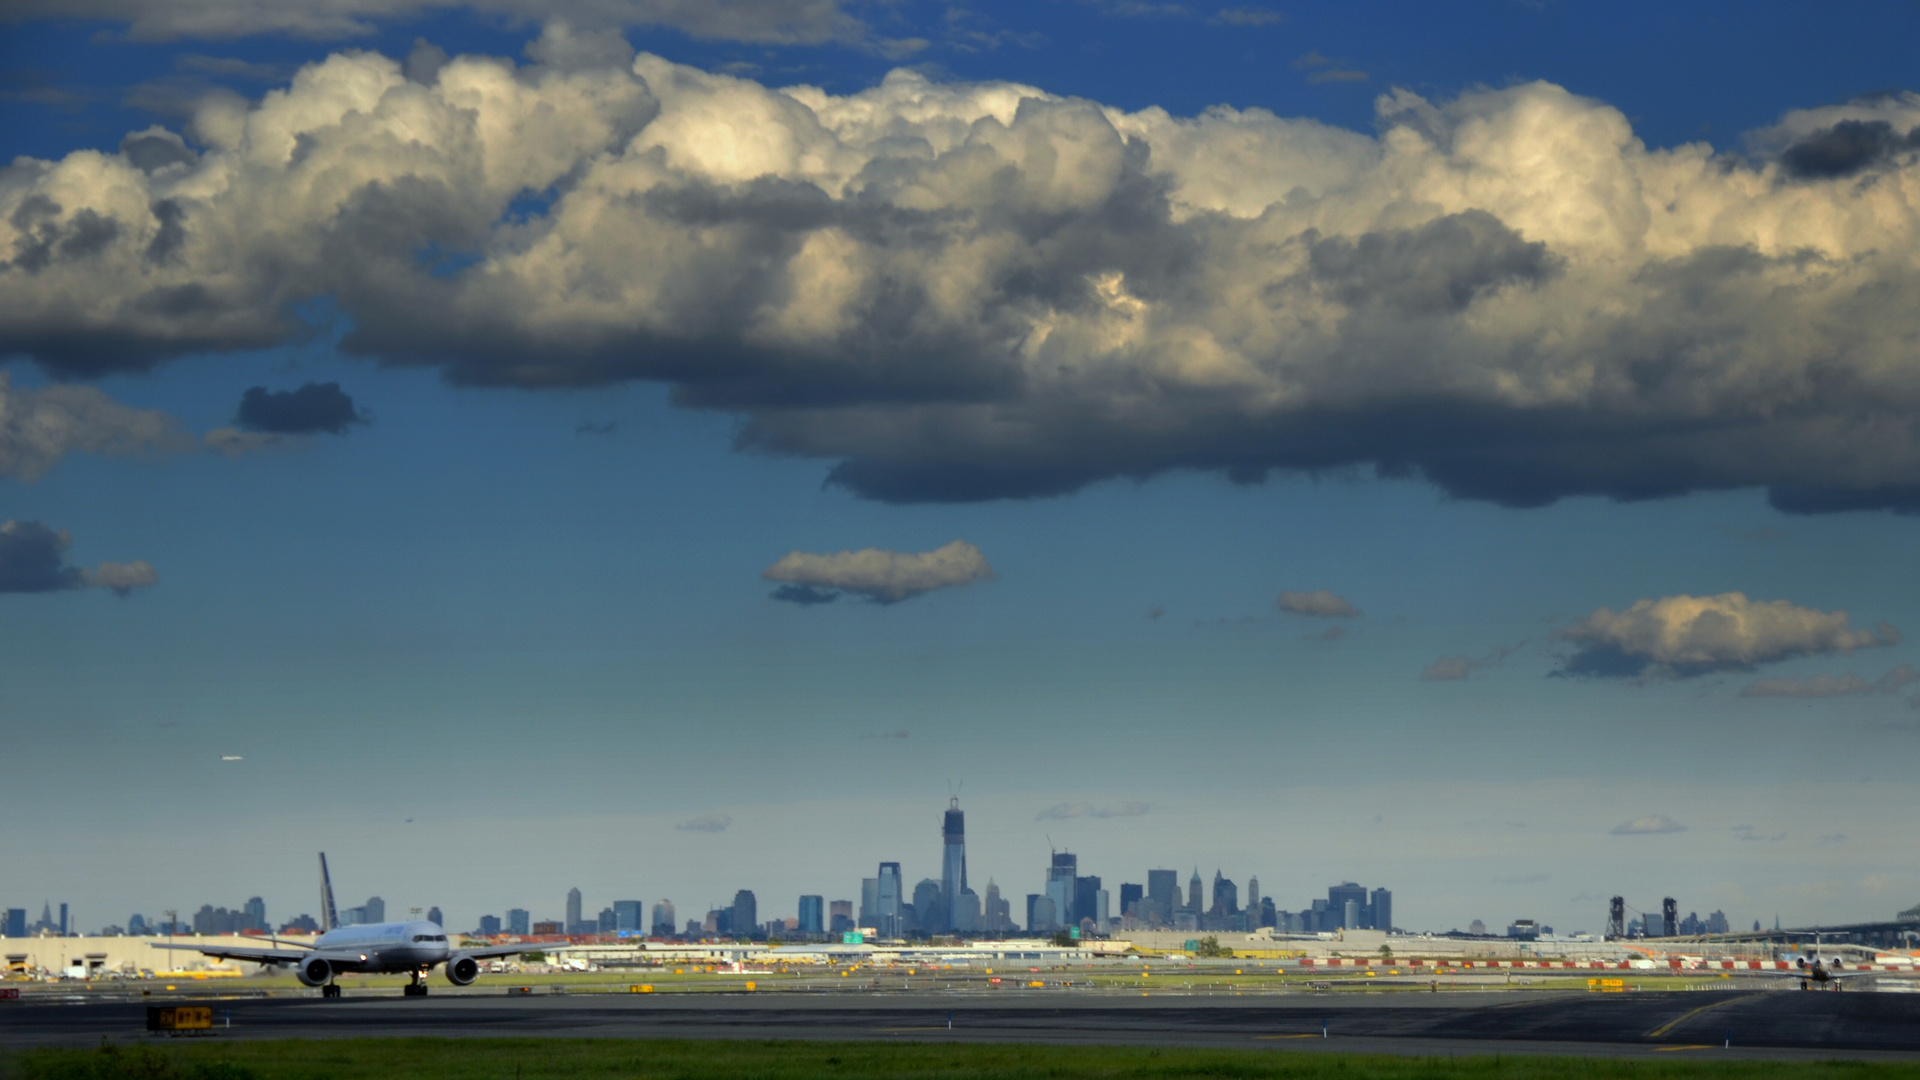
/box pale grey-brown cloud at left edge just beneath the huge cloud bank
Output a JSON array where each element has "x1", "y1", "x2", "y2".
[{"x1": 0, "y1": 374, "x2": 194, "y2": 480}]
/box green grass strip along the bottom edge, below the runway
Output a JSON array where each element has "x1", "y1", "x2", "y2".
[{"x1": 0, "y1": 1040, "x2": 1920, "y2": 1080}]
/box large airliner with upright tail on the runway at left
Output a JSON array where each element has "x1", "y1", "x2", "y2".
[{"x1": 154, "y1": 851, "x2": 566, "y2": 997}]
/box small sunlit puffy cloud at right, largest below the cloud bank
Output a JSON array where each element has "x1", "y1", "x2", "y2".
[{"x1": 1559, "y1": 592, "x2": 1901, "y2": 676}]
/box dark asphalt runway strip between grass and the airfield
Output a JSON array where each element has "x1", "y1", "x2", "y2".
[{"x1": 0, "y1": 990, "x2": 1920, "y2": 1059}]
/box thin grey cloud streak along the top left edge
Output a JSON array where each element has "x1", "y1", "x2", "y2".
[{"x1": 0, "y1": 0, "x2": 893, "y2": 48}]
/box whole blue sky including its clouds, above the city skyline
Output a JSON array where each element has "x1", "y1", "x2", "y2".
[{"x1": 0, "y1": 0, "x2": 1920, "y2": 930}]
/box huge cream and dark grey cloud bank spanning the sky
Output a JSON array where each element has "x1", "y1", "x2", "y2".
[{"x1": 11, "y1": 54, "x2": 1920, "y2": 513}]
